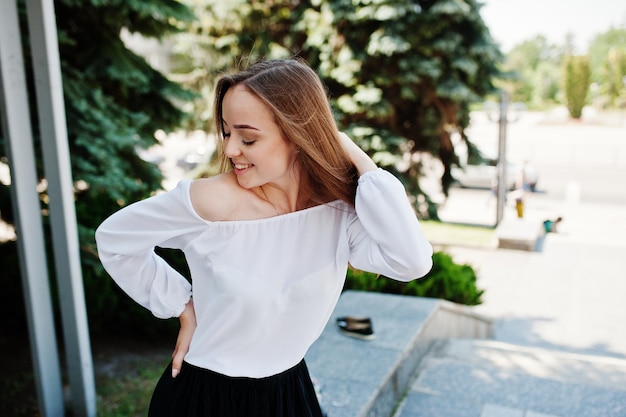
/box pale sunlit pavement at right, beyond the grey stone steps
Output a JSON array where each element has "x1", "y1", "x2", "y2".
[{"x1": 447, "y1": 193, "x2": 626, "y2": 357}]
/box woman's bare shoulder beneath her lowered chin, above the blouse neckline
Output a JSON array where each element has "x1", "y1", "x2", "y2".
[{"x1": 189, "y1": 172, "x2": 248, "y2": 221}]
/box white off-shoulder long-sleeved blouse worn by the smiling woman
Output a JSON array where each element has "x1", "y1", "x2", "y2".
[{"x1": 96, "y1": 168, "x2": 432, "y2": 378}]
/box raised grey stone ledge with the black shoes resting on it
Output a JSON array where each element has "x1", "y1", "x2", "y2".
[{"x1": 305, "y1": 291, "x2": 491, "y2": 417}]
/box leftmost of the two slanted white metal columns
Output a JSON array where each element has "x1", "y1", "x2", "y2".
[{"x1": 0, "y1": 0, "x2": 65, "y2": 417}]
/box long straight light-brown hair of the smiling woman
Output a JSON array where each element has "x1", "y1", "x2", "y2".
[{"x1": 214, "y1": 59, "x2": 358, "y2": 204}]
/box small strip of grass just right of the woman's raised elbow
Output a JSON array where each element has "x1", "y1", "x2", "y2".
[{"x1": 420, "y1": 220, "x2": 496, "y2": 247}]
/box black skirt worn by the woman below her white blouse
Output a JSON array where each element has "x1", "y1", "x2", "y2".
[{"x1": 148, "y1": 360, "x2": 322, "y2": 417}]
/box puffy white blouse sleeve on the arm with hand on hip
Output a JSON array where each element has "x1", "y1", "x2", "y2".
[{"x1": 96, "y1": 181, "x2": 200, "y2": 318}]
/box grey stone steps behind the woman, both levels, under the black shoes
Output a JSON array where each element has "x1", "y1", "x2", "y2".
[{"x1": 306, "y1": 291, "x2": 626, "y2": 417}]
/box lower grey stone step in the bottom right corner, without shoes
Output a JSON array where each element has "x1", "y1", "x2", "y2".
[{"x1": 394, "y1": 339, "x2": 626, "y2": 417}]
